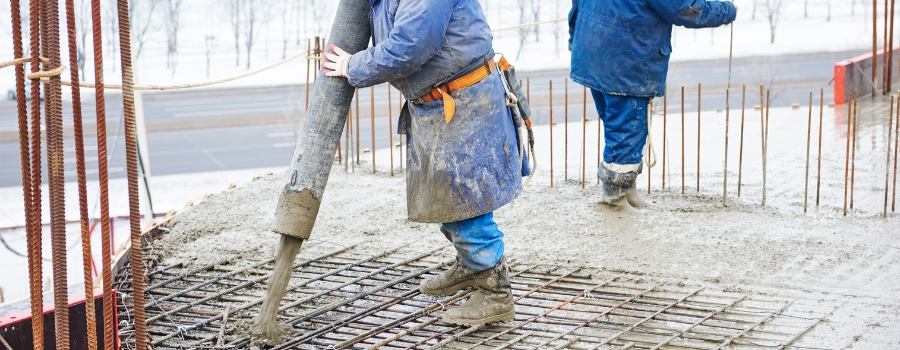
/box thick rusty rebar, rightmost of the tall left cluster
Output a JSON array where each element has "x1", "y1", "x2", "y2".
[{"x1": 117, "y1": 0, "x2": 149, "y2": 350}]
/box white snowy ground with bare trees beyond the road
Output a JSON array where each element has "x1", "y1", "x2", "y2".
[{"x1": 0, "y1": 0, "x2": 900, "y2": 91}]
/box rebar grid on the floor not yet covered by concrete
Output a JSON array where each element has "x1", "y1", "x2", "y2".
[{"x1": 116, "y1": 245, "x2": 838, "y2": 349}]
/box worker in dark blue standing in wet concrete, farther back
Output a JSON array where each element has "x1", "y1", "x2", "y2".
[{"x1": 569, "y1": 0, "x2": 737, "y2": 212}]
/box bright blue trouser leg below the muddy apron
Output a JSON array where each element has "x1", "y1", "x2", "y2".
[{"x1": 441, "y1": 212, "x2": 503, "y2": 273}]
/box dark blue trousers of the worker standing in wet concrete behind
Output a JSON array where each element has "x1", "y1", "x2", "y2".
[{"x1": 591, "y1": 89, "x2": 650, "y2": 165}]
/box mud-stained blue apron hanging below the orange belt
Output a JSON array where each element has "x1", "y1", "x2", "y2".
[{"x1": 400, "y1": 70, "x2": 522, "y2": 223}]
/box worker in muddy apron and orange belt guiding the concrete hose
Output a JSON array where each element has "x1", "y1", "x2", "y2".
[{"x1": 322, "y1": 0, "x2": 530, "y2": 325}]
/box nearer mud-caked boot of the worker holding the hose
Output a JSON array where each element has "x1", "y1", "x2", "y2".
[{"x1": 442, "y1": 259, "x2": 516, "y2": 326}]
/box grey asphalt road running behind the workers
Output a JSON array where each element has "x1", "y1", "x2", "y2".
[{"x1": 0, "y1": 52, "x2": 858, "y2": 187}]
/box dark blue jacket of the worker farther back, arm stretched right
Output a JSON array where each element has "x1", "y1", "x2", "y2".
[{"x1": 569, "y1": 0, "x2": 737, "y2": 97}]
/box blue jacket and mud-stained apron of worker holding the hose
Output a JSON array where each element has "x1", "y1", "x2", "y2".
[{"x1": 348, "y1": 0, "x2": 525, "y2": 223}]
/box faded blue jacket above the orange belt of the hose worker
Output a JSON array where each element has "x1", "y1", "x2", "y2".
[{"x1": 348, "y1": 0, "x2": 493, "y2": 99}]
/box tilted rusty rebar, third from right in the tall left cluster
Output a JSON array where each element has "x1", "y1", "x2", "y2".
[{"x1": 66, "y1": 0, "x2": 97, "y2": 350}]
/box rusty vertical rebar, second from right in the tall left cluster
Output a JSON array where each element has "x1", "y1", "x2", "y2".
[{"x1": 91, "y1": 0, "x2": 117, "y2": 349}]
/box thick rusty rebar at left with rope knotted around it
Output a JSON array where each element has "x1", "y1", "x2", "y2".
[{"x1": 40, "y1": 1, "x2": 71, "y2": 349}]
